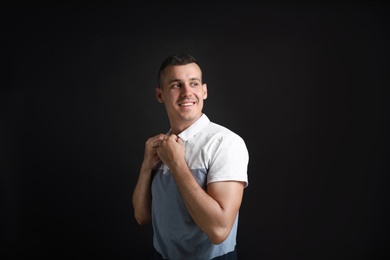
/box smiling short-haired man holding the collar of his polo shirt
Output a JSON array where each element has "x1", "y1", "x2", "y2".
[{"x1": 133, "y1": 54, "x2": 249, "y2": 260}]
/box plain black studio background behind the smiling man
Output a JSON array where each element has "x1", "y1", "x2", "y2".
[{"x1": 0, "y1": 1, "x2": 390, "y2": 259}]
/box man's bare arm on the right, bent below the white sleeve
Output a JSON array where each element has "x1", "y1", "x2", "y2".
[{"x1": 157, "y1": 135, "x2": 244, "y2": 244}]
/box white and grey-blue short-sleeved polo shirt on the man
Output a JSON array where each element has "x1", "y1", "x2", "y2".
[{"x1": 152, "y1": 114, "x2": 249, "y2": 260}]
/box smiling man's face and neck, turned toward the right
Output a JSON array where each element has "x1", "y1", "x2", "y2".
[{"x1": 156, "y1": 63, "x2": 207, "y2": 130}]
